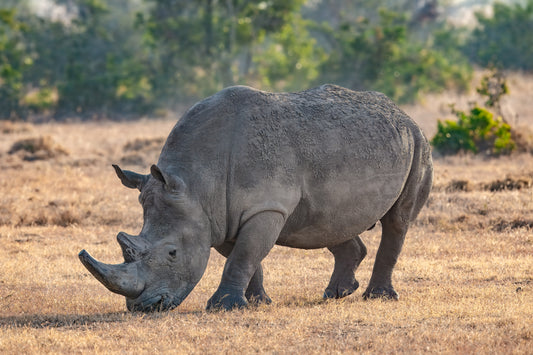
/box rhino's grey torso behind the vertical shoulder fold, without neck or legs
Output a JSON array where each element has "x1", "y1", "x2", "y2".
[{"x1": 229, "y1": 85, "x2": 425, "y2": 248}]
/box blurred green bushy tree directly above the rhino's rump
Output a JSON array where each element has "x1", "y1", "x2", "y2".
[{"x1": 316, "y1": 10, "x2": 471, "y2": 103}]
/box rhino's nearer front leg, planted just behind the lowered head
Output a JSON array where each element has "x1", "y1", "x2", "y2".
[{"x1": 207, "y1": 211, "x2": 284, "y2": 310}]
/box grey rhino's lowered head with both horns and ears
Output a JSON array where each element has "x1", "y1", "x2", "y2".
[{"x1": 79, "y1": 165, "x2": 211, "y2": 312}]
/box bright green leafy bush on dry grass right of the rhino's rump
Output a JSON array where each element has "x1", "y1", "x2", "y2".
[{"x1": 431, "y1": 106, "x2": 515, "y2": 155}]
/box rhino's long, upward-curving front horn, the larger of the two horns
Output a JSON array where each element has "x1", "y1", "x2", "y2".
[{"x1": 78, "y1": 250, "x2": 144, "y2": 298}]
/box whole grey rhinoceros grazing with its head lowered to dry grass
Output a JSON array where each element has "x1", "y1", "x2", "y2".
[{"x1": 79, "y1": 85, "x2": 433, "y2": 312}]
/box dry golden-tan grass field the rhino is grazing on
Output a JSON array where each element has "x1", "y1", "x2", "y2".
[{"x1": 0, "y1": 75, "x2": 533, "y2": 354}]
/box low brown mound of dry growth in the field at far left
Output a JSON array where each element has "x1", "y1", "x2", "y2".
[{"x1": 8, "y1": 136, "x2": 69, "y2": 161}]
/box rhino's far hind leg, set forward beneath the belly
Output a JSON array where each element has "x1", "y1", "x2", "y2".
[{"x1": 324, "y1": 236, "x2": 366, "y2": 299}]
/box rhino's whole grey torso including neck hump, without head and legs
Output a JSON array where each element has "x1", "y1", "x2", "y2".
[{"x1": 158, "y1": 85, "x2": 427, "y2": 248}]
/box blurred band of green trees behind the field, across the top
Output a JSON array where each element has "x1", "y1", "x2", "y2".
[{"x1": 0, "y1": 0, "x2": 533, "y2": 121}]
